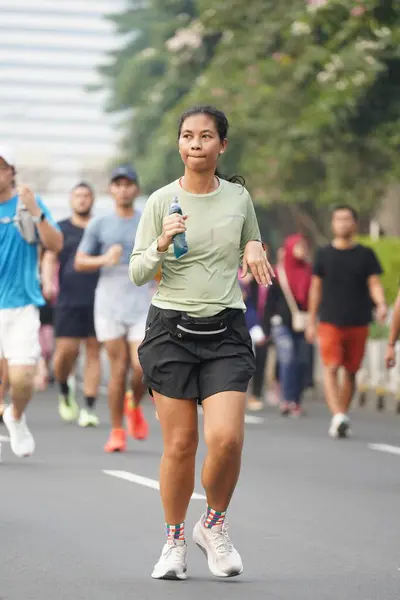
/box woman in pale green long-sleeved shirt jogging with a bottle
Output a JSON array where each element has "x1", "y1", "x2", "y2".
[{"x1": 129, "y1": 106, "x2": 272, "y2": 579}]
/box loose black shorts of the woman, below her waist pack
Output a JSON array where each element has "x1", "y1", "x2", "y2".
[{"x1": 139, "y1": 305, "x2": 255, "y2": 403}]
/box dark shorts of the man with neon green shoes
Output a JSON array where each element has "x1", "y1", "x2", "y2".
[{"x1": 54, "y1": 306, "x2": 96, "y2": 338}]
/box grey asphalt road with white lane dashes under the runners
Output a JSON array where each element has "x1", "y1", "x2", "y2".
[{"x1": 0, "y1": 393, "x2": 400, "y2": 600}]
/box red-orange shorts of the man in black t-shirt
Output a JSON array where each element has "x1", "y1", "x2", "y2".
[{"x1": 318, "y1": 323, "x2": 368, "y2": 373}]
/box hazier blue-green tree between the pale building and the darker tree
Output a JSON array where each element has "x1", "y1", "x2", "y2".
[{"x1": 99, "y1": 0, "x2": 219, "y2": 190}]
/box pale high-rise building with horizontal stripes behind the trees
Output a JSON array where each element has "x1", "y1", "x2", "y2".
[{"x1": 0, "y1": 0, "x2": 125, "y2": 218}]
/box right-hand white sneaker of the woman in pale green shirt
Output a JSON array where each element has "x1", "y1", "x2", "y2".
[{"x1": 193, "y1": 515, "x2": 243, "y2": 577}]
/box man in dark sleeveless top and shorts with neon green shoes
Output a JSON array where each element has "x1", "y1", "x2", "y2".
[{"x1": 43, "y1": 181, "x2": 100, "y2": 427}]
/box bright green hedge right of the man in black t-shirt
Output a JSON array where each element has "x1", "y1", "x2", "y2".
[{"x1": 358, "y1": 236, "x2": 400, "y2": 305}]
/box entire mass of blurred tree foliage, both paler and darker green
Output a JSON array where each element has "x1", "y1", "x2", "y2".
[{"x1": 99, "y1": 0, "x2": 400, "y2": 212}]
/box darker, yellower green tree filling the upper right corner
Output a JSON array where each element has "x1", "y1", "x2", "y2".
[{"x1": 166, "y1": 0, "x2": 400, "y2": 216}]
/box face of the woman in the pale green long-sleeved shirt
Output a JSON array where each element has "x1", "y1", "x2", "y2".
[{"x1": 179, "y1": 114, "x2": 227, "y2": 173}]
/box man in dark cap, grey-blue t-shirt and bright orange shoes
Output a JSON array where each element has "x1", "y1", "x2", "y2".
[{"x1": 75, "y1": 165, "x2": 151, "y2": 452}]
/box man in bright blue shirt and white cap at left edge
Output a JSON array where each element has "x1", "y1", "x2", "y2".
[{"x1": 0, "y1": 146, "x2": 63, "y2": 457}]
